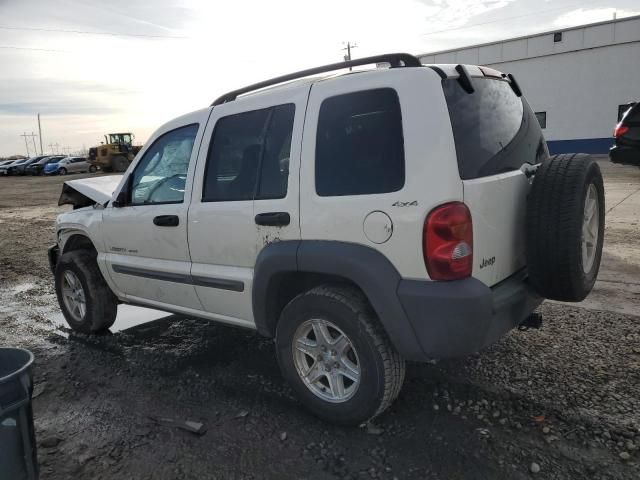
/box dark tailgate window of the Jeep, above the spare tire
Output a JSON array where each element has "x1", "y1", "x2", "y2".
[{"x1": 442, "y1": 77, "x2": 548, "y2": 180}]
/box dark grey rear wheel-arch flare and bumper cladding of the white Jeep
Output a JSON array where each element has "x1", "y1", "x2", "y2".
[{"x1": 253, "y1": 240, "x2": 542, "y2": 361}]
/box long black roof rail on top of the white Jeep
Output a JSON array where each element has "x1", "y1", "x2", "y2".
[{"x1": 211, "y1": 53, "x2": 422, "y2": 107}]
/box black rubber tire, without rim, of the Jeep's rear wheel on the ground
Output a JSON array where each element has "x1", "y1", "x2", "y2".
[{"x1": 276, "y1": 285, "x2": 405, "y2": 425}]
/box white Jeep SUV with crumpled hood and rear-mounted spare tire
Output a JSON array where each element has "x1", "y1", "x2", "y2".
[{"x1": 49, "y1": 54, "x2": 604, "y2": 424}]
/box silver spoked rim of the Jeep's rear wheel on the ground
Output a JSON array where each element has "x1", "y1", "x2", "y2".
[{"x1": 292, "y1": 319, "x2": 361, "y2": 403}]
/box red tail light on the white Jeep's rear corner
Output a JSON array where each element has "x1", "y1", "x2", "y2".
[{"x1": 422, "y1": 202, "x2": 473, "y2": 280}]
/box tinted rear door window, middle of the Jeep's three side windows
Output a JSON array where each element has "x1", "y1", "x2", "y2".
[{"x1": 202, "y1": 104, "x2": 295, "y2": 202}]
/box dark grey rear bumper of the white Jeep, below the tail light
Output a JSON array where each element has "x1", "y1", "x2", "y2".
[{"x1": 398, "y1": 270, "x2": 543, "y2": 358}]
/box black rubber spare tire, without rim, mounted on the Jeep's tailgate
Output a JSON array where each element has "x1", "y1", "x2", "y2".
[{"x1": 526, "y1": 153, "x2": 605, "y2": 302}]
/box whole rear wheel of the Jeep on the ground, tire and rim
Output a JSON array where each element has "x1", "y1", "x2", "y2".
[{"x1": 276, "y1": 286, "x2": 405, "y2": 425}]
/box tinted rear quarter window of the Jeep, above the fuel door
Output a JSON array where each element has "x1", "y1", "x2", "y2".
[{"x1": 315, "y1": 88, "x2": 405, "y2": 197}]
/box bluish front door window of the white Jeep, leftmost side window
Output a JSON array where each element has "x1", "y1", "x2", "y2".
[{"x1": 131, "y1": 124, "x2": 198, "y2": 205}]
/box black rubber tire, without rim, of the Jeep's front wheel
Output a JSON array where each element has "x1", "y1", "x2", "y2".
[{"x1": 55, "y1": 250, "x2": 118, "y2": 333}]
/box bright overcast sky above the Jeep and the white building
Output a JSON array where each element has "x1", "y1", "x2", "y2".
[{"x1": 0, "y1": 0, "x2": 640, "y2": 156}]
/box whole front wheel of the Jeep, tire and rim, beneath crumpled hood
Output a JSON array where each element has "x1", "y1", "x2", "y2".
[{"x1": 55, "y1": 250, "x2": 118, "y2": 333}]
